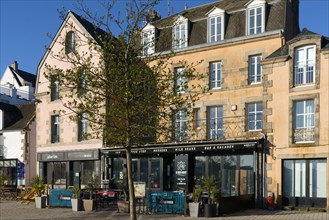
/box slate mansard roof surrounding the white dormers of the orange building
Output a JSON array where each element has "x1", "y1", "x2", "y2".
[{"x1": 150, "y1": 0, "x2": 286, "y2": 52}]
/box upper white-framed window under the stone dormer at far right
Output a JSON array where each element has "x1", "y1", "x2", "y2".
[{"x1": 294, "y1": 45, "x2": 315, "y2": 86}]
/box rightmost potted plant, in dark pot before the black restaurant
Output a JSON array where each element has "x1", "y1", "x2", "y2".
[{"x1": 202, "y1": 176, "x2": 219, "y2": 217}]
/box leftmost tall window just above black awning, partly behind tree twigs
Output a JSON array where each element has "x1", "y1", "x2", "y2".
[{"x1": 174, "y1": 110, "x2": 187, "y2": 141}]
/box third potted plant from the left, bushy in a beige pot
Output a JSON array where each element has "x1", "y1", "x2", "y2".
[{"x1": 82, "y1": 172, "x2": 100, "y2": 211}]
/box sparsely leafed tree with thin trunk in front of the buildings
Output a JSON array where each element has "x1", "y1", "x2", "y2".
[{"x1": 46, "y1": 0, "x2": 208, "y2": 219}]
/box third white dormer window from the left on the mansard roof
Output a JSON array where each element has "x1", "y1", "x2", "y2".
[{"x1": 208, "y1": 8, "x2": 225, "y2": 42}]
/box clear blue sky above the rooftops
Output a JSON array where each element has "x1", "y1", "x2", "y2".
[{"x1": 0, "y1": 0, "x2": 329, "y2": 77}]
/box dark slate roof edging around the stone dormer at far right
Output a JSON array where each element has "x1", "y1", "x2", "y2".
[{"x1": 266, "y1": 28, "x2": 329, "y2": 59}]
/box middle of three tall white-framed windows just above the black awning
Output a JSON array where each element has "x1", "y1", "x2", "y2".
[{"x1": 208, "y1": 106, "x2": 224, "y2": 140}]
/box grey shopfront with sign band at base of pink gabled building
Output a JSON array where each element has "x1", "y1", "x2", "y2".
[{"x1": 37, "y1": 150, "x2": 100, "y2": 189}]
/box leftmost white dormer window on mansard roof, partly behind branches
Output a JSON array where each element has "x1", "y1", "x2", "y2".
[{"x1": 142, "y1": 24, "x2": 155, "y2": 56}]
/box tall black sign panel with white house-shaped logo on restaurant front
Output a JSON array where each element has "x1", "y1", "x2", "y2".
[{"x1": 175, "y1": 154, "x2": 188, "y2": 191}]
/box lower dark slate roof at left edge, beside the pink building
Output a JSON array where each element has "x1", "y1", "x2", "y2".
[{"x1": 0, "y1": 103, "x2": 36, "y2": 131}]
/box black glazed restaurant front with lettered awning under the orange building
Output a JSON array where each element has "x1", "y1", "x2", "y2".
[{"x1": 101, "y1": 139, "x2": 265, "y2": 211}]
